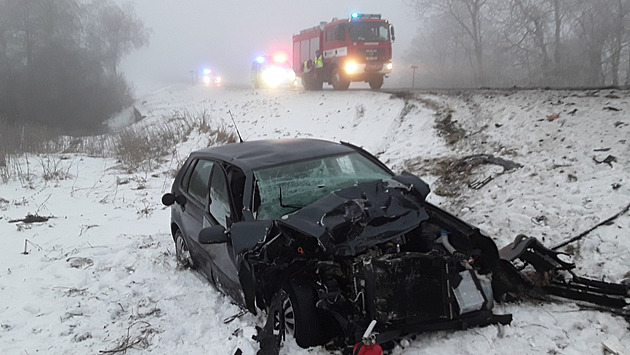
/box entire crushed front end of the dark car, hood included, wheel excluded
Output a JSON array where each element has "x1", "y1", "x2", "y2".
[{"x1": 232, "y1": 174, "x2": 511, "y2": 345}]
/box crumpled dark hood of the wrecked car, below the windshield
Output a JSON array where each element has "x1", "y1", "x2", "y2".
[{"x1": 277, "y1": 175, "x2": 429, "y2": 256}]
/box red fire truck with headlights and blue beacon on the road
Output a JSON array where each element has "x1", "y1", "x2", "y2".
[{"x1": 293, "y1": 13, "x2": 395, "y2": 90}]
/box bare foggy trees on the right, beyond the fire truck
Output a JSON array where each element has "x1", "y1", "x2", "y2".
[{"x1": 406, "y1": 0, "x2": 630, "y2": 87}]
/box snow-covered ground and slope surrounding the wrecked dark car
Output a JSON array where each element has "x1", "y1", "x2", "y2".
[{"x1": 0, "y1": 86, "x2": 630, "y2": 354}]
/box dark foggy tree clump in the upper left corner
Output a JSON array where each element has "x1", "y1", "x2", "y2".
[{"x1": 0, "y1": 0, "x2": 149, "y2": 132}]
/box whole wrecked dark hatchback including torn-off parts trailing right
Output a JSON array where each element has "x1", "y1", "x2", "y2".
[{"x1": 162, "y1": 139, "x2": 628, "y2": 353}]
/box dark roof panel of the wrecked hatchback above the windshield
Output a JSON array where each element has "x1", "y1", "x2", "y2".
[{"x1": 191, "y1": 138, "x2": 355, "y2": 170}]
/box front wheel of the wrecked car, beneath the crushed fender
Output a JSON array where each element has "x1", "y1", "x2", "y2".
[{"x1": 282, "y1": 280, "x2": 330, "y2": 348}]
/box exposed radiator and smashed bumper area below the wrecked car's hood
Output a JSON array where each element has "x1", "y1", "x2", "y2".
[{"x1": 318, "y1": 252, "x2": 512, "y2": 344}]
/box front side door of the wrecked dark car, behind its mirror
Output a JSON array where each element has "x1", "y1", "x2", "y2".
[{"x1": 203, "y1": 164, "x2": 244, "y2": 303}]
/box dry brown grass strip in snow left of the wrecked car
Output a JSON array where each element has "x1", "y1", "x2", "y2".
[{"x1": 0, "y1": 109, "x2": 237, "y2": 183}]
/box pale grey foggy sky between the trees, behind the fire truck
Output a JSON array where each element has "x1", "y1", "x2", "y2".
[{"x1": 121, "y1": 0, "x2": 417, "y2": 95}]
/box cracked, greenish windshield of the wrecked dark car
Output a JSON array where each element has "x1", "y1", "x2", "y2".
[{"x1": 254, "y1": 153, "x2": 391, "y2": 220}]
